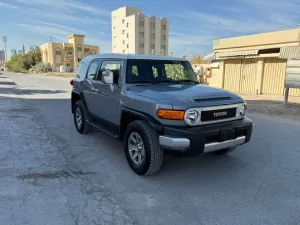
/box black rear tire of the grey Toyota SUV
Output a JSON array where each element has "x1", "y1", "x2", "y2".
[{"x1": 73, "y1": 100, "x2": 93, "y2": 134}]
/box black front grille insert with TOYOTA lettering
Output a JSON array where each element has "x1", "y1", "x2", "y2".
[{"x1": 201, "y1": 108, "x2": 236, "y2": 122}]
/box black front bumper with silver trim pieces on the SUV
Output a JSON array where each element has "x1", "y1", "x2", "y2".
[{"x1": 159, "y1": 117, "x2": 253, "y2": 155}]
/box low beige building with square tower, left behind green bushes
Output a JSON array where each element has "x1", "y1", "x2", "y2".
[{"x1": 40, "y1": 34, "x2": 100, "y2": 72}]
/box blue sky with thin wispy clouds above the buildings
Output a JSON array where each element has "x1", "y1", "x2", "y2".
[{"x1": 0, "y1": 0, "x2": 300, "y2": 56}]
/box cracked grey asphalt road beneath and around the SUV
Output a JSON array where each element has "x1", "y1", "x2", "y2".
[{"x1": 0, "y1": 73, "x2": 300, "y2": 225}]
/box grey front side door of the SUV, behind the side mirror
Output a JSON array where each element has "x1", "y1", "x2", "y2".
[{"x1": 96, "y1": 60, "x2": 122, "y2": 126}]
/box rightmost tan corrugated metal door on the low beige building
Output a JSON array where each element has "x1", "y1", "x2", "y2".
[{"x1": 262, "y1": 58, "x2": 286, "y2": 95}]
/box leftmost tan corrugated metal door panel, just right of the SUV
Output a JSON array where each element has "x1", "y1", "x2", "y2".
[{"x1": 224, "y1": 60, "x2": 241, "y2": 92}]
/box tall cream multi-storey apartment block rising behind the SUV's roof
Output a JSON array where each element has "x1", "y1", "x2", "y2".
[{"x1": 111, "y1": 7, "x2": 169, "y2": 55}]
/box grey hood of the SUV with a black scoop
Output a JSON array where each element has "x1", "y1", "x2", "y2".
[{"x1": 129, "y1": 84, "x2": 242, "y2": 103}]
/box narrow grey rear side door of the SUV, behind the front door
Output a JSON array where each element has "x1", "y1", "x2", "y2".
[{"x1": 83, "y1": 59, "x2": 101, "y2": 116}]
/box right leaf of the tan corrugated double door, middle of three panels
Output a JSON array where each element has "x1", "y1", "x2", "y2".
[{"x1": 239, "y1": 59, "x2": 257, "y2": 93}]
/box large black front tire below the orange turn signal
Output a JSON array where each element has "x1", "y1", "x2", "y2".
[{"x1": 124, "y1": 120, "x2": 163, "y2": 176}]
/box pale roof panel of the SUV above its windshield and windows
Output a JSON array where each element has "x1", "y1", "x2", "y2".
[{"x1": 85, "y1": 53, "x2": 187, "y2": 61}]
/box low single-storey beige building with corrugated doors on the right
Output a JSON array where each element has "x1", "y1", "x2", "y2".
[{"x1": 208, "y1": 29, "x2": 300, "y2": 96}]
